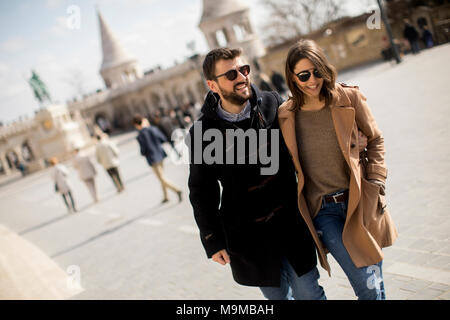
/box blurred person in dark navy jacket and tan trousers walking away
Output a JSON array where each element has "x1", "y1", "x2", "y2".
[{"x1": 133, "y1": 115, "x2": 182, "y2": 203}]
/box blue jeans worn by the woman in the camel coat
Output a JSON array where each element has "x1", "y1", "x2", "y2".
[{"x1": 313, "y1": 192, "x2": 386, "y2": 300}]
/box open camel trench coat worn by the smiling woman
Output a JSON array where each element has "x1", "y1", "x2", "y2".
[{"x1": 278, "y1": 84, "x2": 397, "y2": 275}]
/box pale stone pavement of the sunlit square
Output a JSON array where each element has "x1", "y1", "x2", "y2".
[{"x1": 0, "y1": 45, "x2": 450, "y2": 300}]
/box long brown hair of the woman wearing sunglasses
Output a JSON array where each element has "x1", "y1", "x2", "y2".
[{"x1": 285, "y1": 39, "x2": 337, "y2": 110}]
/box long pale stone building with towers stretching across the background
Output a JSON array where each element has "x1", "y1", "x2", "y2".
[{"x1": 0, "y1": 0, "x2": 450, "y2": 180}]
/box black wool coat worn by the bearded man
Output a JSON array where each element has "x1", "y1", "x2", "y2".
[{"x1": 186, "y1": 86, "x2": 317, "y2": 287}]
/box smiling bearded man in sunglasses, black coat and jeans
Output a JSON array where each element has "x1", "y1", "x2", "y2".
[{"x1": 187, "y1": 48, "x2": 325, "y2": 299}]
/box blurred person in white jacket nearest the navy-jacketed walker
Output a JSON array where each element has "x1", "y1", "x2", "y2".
[{"x1": 95, "y1": 135, "x2": 124, "y2": 192}]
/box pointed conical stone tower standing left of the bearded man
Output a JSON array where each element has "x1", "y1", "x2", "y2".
[{"x1": 98, "y1": 12, "x2": 142, "y2": 89}]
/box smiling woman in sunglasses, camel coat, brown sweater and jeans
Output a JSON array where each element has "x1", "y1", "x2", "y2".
[{"x1": 279, "y1": 40, "x2": 397, "y2": 299}]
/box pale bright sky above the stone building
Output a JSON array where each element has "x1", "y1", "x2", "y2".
[{"x1": 0, "y1": 0, "x2": 370, "y2": 124}]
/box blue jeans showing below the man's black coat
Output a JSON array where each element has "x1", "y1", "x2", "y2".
[{"x1": 260, "y1": 258, "x2": 327, "y2": 300}]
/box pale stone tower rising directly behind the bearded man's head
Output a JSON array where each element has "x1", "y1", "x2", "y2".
[{"x1": 199, "y1": 0, "x2": 265, "y2": 63}]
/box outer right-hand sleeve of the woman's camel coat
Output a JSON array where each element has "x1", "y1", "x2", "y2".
[{"x1": 352, "y1": 89, "x2": 387, "y2": 182}]
